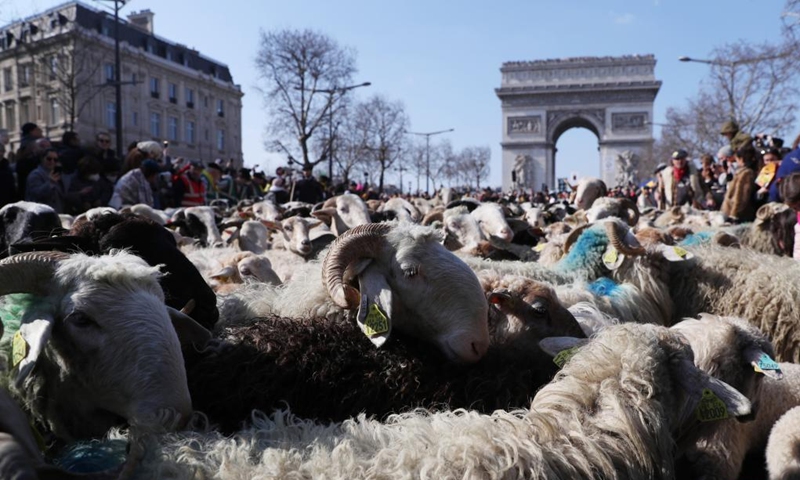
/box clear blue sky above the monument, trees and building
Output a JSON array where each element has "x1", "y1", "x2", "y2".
[{"x1": 0, "y1": 0, "x2": 797, "y2": 185}]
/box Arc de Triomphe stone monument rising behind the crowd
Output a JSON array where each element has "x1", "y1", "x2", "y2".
[{"x1": 495, "y1": 55, "x2": 661, "y2": 191}]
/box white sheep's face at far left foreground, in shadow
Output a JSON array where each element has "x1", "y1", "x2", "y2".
[{"x1": 5, "y1": 253, "x2": 192, "y2": 440}]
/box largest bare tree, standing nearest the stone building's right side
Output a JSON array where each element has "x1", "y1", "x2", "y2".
[{"x1": 255, "y1": 30, "x2": 356, "y2": 166}]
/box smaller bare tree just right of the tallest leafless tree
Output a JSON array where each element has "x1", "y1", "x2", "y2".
[{"x1": 356, "y1": 95, "x2": 409, "y2": 193}]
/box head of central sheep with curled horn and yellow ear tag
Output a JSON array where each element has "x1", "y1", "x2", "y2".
[{"x1": 322, "y1": 223, "x2": 489, "y2": 362}]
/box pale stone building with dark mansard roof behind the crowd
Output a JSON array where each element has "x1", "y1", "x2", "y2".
[{"x1": 0, "y1": 2, "x2": 244, "y2": 166}]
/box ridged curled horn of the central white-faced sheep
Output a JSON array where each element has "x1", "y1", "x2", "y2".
[{"x1": 322, "y1": 223, "x2": 391, "y2": 309}]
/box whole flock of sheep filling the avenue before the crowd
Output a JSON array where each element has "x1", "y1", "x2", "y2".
[{"x1": 0, "y1": 177, "x2": 800, "y2": 479}]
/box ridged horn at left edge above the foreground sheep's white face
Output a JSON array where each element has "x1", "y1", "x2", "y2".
[{"x1": 0, "y1": 252, "x2": 69, "y2": 295}]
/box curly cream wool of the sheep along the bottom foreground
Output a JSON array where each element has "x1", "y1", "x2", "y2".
[{"x1": 140, "y1": 324, "x2": 720, "y2": 479}]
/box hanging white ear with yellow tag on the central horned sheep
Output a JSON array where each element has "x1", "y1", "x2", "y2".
[{"x1": 356, "y1": 268, "x2": 392, "y2": 347}]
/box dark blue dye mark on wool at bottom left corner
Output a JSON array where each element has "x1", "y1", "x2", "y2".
[{"x1": 53, "y1": 440, "x2": 128, "y2": 473}]
